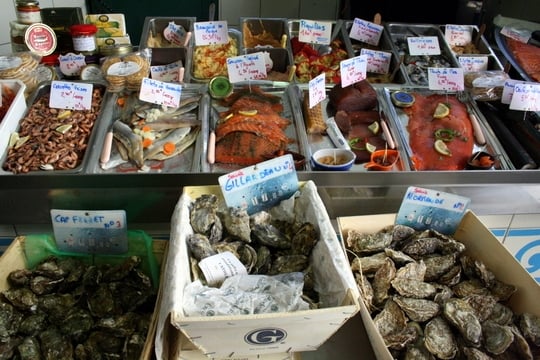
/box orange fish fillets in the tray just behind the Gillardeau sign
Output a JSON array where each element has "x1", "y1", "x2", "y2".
[{"x1": 210, "y1": 85, "x2": 302, "y2": 170}]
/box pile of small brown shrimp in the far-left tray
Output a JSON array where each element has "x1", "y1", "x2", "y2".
[{"x1": 2, "y1": 85, "x2": 105, "y2": 174}]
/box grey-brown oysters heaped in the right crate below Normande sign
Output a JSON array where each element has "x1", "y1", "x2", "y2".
[{"x1": 346, "y1": 225, "x2": 540, "y2": 359}]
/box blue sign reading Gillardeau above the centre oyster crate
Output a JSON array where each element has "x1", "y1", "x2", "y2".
[{"x1": 218, "y1": 154, "x2": 298, "y2": 215}]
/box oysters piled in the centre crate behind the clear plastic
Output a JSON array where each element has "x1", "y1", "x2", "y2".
[{"x1": 187, "y1": 194, "x2": 319, "y2": 306}]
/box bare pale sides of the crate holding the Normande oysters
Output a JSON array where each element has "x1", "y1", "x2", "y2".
[{"x1": 337, "y1": 211, "x2": 540, "y2": 360}]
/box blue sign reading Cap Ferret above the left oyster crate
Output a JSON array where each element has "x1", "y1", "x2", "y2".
[{"x1": 51, "y1": 209, "x2": 128, "y2": 254}]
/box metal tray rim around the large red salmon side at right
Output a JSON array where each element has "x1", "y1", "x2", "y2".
[{"x1": 379, "y1": 87, "x2": 514, "y2": 171}]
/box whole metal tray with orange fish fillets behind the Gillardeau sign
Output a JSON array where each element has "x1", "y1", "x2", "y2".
[{"x1": 201, "y1": 81, "x2": 307, "y2": 172}]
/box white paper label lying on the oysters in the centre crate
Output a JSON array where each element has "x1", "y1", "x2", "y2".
[{"x1": 199, "y1": 251, "x2": 247, "y2": 286}]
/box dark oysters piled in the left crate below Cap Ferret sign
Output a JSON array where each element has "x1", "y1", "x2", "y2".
[{"x1": 0, "y1": 256, "x2": 156, "y2": 360}]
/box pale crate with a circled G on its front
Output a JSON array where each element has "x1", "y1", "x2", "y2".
[{"x1": 155, "y1": 181, "x2": 360, "y2": 359}]
